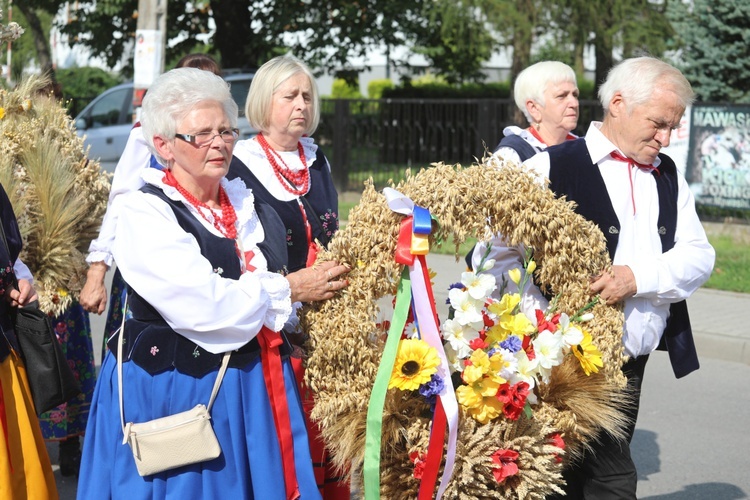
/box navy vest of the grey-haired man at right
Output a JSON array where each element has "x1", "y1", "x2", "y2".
[{"x1": 547, "y1": 139, "x2": 700, "y2": 378}]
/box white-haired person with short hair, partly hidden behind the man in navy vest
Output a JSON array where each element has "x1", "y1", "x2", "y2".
[{"x1": 494, "y1": 61, "x2": 578, "y2": 164}]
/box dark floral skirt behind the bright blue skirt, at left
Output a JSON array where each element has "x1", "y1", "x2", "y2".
[{"x1": 39, "y1": 302, "x2": 96, "y2": 441}]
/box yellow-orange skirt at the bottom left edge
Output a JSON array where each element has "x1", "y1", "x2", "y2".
[{"x1": 0, "y1": 354, "x2": 58, "y2": 500}]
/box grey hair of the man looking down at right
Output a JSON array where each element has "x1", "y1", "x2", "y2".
[{"x1": 599, "y1": 56, "x2": 695, "y2": 114}]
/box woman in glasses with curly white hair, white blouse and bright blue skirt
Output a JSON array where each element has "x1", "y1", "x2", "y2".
[{"x1": 78, "y1": 68, "x2": 346, "y2": 499}]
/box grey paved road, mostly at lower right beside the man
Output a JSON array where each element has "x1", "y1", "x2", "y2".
[{"x1": 57, "y1": 255, "x2": 750, "y2": 500}]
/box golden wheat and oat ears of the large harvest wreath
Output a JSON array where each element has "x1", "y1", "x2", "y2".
[{"x1": 302, "y1": 164, "x2": 627, "y2": 499}]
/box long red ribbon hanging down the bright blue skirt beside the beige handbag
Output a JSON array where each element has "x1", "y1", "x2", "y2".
[{"x1": 258, "y1": 326, "x2": 300, "y2": 500}]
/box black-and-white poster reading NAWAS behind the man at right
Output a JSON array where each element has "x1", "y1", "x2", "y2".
[{"x1": 685, "y1": 104, "x2": 750, "y2": 209}]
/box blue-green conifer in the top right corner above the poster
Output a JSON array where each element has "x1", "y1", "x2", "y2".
[{"x1": 669, "y1": 0, "x2": 750, "y2": 103}]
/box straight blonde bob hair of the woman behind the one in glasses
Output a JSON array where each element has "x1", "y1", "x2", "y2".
[{"x1": 245, "y1": 56, "x2": 320, "y2": 135}]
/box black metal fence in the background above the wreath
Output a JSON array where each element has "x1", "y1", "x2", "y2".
[{"x1": 315, "y1": 99, "x2": 602, "y2": 191}]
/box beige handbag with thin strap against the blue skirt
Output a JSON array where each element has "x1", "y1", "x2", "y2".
[{"x1": 117, "y1": 311, "x2": 231, "y2": 476}]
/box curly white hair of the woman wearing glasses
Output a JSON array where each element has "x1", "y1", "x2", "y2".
[{"x1": 141, "y1": 68, "x2": 238, "y2": 164}]
